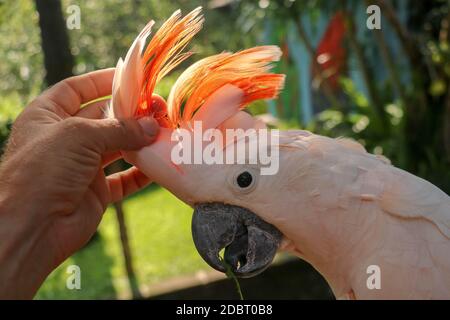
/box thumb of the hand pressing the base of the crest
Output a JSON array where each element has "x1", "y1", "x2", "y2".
[{"x1": 77, "y1": 117, "x2": 159, "y2": 153}]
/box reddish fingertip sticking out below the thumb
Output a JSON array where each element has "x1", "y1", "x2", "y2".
[{"x1": 106, "y1": 167, "x2": 150, "y2": 202}]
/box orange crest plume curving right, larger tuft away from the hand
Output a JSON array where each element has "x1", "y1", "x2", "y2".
[{"x1": 167, "y1": 46, "x2": 285, "y2": 127}]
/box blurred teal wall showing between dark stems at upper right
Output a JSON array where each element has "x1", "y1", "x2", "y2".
[{"x1": 264, "y1": 0, "x2": 410, "y2": 124}]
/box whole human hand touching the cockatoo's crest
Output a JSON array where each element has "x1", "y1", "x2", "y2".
[{"x1": 0, "y1": 69, "x2": 159, "y2": 299}]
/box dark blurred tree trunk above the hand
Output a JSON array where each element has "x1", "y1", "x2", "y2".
[{"x1": 35, "y1": 0, "x2": 74, "y2": 86}]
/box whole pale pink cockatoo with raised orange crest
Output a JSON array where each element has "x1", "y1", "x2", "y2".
[{"x1": 109, "y1": 8, "x2": 450, "y2": 299}]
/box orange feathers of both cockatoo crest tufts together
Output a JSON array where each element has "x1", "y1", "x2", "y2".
[{"x1": 136, "y1": 7, "x2": 285, "y2": 128}]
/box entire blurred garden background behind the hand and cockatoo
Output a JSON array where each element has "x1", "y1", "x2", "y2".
[{"x1": 0, "y1": 0, "x2": 450, "y2": 299}]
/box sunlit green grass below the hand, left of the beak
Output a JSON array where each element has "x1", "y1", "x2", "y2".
[{"x1": 36, "y1": 186, "x2": 210, "y2": 299}]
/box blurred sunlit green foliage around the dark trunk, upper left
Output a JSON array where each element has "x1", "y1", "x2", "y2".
[{"x1": 0, "y1": 0, "x2": 255, "y2": 108}]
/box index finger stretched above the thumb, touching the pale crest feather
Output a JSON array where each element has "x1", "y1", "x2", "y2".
[{"x1": 38, "y1": 68, "x2": 114, "y2": 115}]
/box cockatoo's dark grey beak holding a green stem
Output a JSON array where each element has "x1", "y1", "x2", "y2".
[{"x1": 192, "y1": 203, "x2": 282, "y2": 278}]
